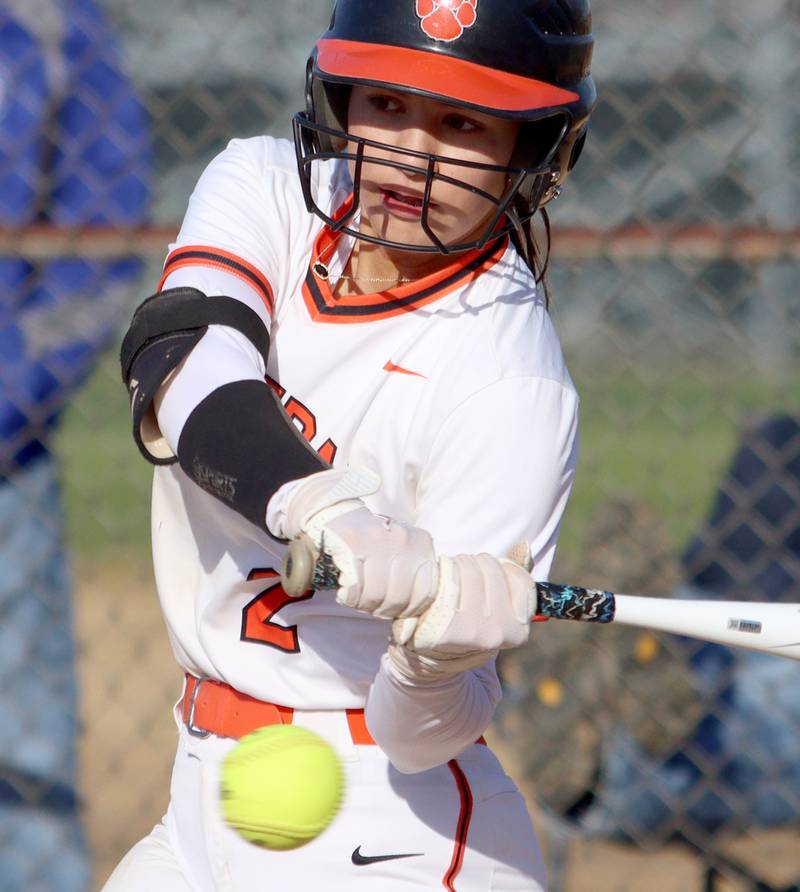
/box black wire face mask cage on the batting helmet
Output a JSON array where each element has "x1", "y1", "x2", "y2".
[{"x1": 292, "y1": 112, "x2": 563, "y2": 254}]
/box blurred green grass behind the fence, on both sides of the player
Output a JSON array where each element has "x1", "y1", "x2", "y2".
[{"x1": 58, "y1": 346, "x2": 800, "y2": 562}]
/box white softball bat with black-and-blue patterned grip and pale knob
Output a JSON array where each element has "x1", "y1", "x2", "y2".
[{"x1": 281, "y1": 538, "x2": 800, "y2": 660}]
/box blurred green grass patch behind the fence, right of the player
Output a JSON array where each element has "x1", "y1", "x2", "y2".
[{"x1": 560, "y1": 360, "x2": 800, "y2": 557}]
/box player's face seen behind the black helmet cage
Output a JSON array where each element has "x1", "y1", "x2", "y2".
[{"x1": 348, "y1": 86, "x2": 519, "y2": 251}]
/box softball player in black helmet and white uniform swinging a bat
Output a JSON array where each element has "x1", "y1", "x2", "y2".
[{"x1": 106, "y1": 0, "x2": 594, "y2": 892}]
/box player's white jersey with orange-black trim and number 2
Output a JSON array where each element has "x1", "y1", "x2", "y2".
[{"x1": 152, "y1": 137, "x2": 578, "y2": 709}]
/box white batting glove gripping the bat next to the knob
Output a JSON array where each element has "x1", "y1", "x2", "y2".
[{"x1": 268, "y1": 467, "x2": 438, "y2": 619}]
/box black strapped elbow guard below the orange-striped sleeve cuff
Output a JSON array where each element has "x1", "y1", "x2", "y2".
[{"x1": 120, "y1": 288, "x2": 269, "y2": 465}]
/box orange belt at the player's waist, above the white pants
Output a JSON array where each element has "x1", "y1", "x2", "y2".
[{"x1": 181, "y1": 672, "x2": 486, "y2": 746}]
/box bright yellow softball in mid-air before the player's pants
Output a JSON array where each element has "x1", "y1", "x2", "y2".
[{"x1": 220, "y1": 725, "x2": 344, "y2": 850}]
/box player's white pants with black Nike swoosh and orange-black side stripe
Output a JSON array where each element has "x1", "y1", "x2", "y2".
[{"x1": 104, "y1": 712, "x2": 545, "y2": 892}]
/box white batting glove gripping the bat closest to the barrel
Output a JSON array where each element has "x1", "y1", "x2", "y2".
[{"x1": 389, "y1": 554, "x2": 536, "y2": 678}]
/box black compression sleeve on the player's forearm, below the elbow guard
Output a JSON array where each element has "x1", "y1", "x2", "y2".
[{"x1": 178, "y1": 381, "x2": 330, "y2": 530}]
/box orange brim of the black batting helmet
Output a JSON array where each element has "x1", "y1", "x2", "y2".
[{"x1": 317, "y1": 39, "x2": 580, "y2": 112}]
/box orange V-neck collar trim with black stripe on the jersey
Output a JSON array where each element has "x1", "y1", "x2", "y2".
[{"x1": 303, "y1": 204, "x2": 508, "y2": 324}]
